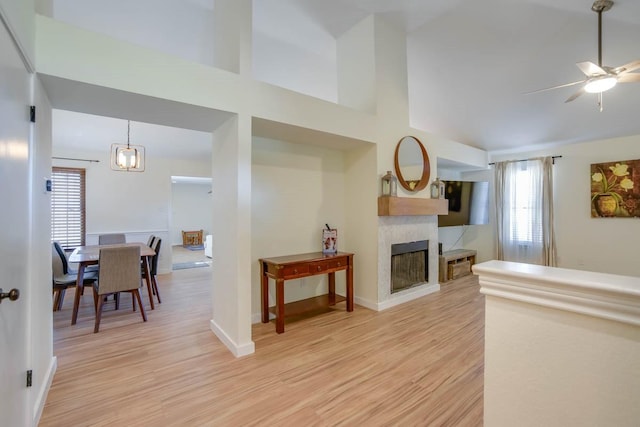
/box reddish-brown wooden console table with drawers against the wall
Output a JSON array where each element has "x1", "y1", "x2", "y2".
[{"x1": 259, "y1": 252, "x2": 353, "y2": 334}]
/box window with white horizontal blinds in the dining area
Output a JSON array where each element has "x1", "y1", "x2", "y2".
[{"x1": 51, "y1": 167, "x2": 85, "y2": 249}]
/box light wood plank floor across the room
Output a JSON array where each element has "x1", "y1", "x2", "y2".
[{"x1": 40, "y1": 268, "x2": 484, "y2": 426}]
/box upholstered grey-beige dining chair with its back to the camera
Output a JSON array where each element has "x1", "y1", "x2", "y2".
[{"x1": 93, "y1": 246, "x2": 147, "y2": 333}]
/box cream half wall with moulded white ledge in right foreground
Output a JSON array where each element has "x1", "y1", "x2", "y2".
[{"x1": 473, "y1": 261, "x2": 640, "y2": 427}]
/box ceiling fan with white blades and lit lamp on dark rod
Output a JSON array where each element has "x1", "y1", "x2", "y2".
[{"x1": 529, "y1": 0, "x2": 640, "y2": 111}]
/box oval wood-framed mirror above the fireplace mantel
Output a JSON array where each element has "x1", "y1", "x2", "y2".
[{"x1": 395, "y1": 136, "x2": 431, "y2": 191}]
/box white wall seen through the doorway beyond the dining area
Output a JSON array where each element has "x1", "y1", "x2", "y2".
[{"x1": 171, "y1": 182, "x2": 213, "y2": 245}]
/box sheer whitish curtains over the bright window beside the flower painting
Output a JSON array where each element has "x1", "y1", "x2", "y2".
[{"x1": 494, "y1": 157, "x2": 556, "y2": 266}]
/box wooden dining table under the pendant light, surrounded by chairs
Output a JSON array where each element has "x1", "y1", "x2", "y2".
[{"x1": 69, "y1": 242, "x2": 156, "y2": 325}]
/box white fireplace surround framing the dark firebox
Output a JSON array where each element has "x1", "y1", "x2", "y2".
[{"x1": 375, "y1": 215, "x2": 440, "y2": 310}]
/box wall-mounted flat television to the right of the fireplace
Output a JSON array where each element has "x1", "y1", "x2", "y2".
[{"x1": 438, "y1": 180, "x2": 489, "y2": 227}]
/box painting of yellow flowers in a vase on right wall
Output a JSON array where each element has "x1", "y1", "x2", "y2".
[{"x1": 591, "y1": 160, "x2": 640, "y2": 218}]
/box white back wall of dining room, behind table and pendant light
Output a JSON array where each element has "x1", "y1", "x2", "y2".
[{"x1": 53, "y1": 148, "x2": 211, "y2": 274}]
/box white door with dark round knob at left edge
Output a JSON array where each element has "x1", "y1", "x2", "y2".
[{"x1": 0, "y1": 14, "x2": 32, "y2": 426}]
